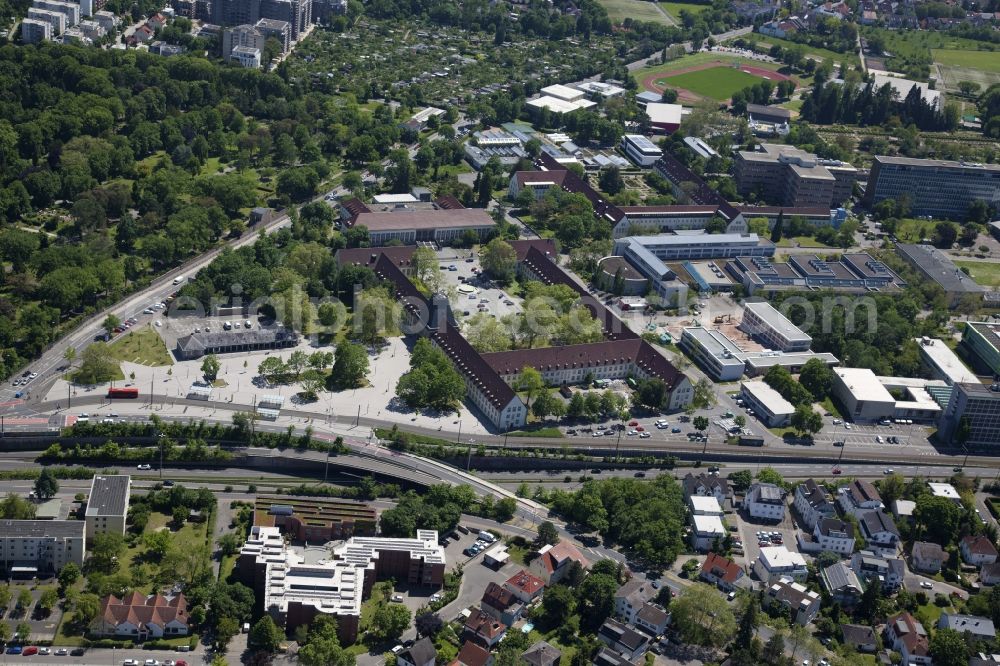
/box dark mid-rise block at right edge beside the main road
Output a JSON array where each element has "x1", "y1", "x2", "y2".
[{"x1": 938, "y1": 383, "x2": 1000, "y2": 447}]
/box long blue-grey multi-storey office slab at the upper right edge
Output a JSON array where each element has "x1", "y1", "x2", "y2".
[{"x1": 864, "y1": 155, "x2": 1000, "y2": 220}]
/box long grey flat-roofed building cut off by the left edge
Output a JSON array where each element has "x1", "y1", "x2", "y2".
[{"x1": 0, "y1": 520, "x2": 87, "y2": 577}]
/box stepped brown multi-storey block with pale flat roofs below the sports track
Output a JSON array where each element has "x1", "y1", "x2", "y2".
[{"x1": 735, "y1": 143, "x2": 858, "y2": 207}]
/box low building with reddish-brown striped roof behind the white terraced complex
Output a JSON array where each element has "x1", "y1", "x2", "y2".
[{"x1": 254, "y1": 495, "x2": 378, "y2": 543}]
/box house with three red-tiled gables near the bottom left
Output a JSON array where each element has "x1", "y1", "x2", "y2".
[{"x1": 90, "y1": 592, "x2": 189, "y2": 641}]
